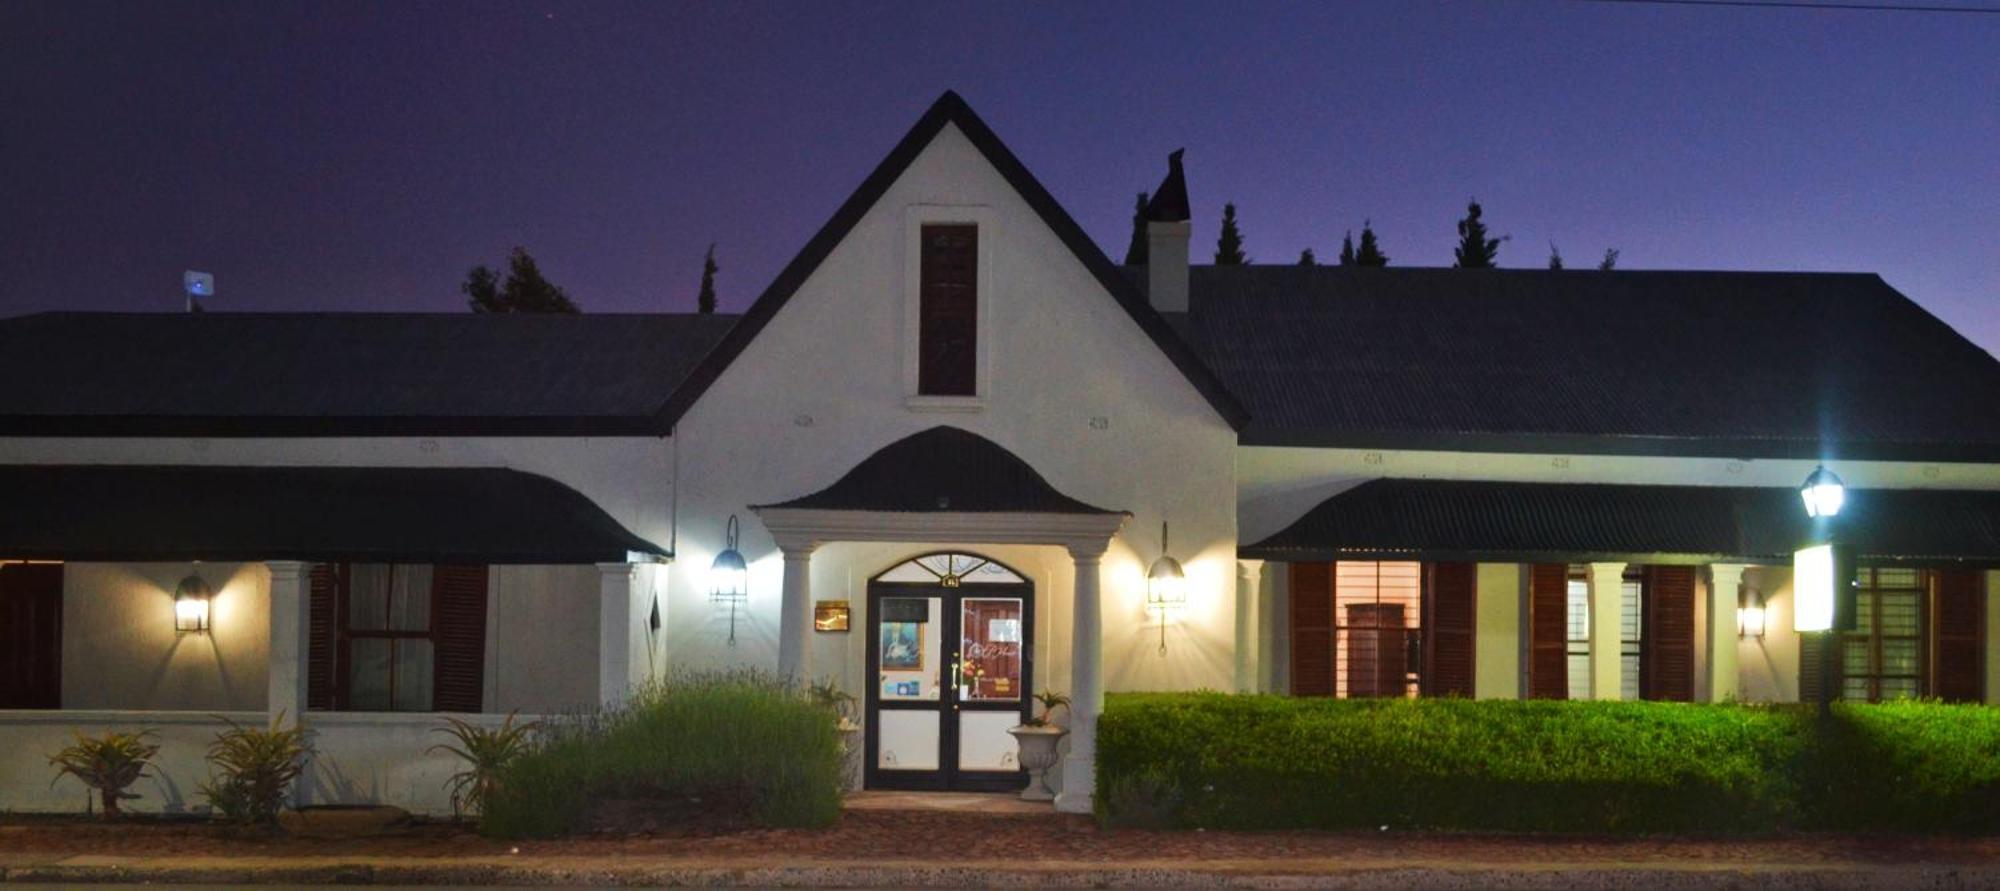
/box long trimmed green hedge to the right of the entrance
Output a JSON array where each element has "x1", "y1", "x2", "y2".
[{"x1": 1098, "y1": 693, "x2": 2000, "y2": 833}]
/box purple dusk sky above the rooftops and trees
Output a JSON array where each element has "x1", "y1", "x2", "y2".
[{"x1": 0, "y1": 0, "x2": 2000, "y2": 362}]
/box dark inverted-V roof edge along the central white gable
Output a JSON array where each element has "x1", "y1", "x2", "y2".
[{"x1": 660, "y1": 92, "x2": 1250, "y2": 430}]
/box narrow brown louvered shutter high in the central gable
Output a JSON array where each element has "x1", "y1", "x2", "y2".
[{"x1": 916, "y1": 226, "x2": 980, "y2": 396}]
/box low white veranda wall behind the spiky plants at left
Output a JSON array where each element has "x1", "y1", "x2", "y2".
[{"x1": 0, "y1": 711, "x2": 530, "y2": 815}]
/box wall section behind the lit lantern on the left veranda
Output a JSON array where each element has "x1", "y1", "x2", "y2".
[{"x1": 62, "y1": 563, "x2": 270, "y2": 711}]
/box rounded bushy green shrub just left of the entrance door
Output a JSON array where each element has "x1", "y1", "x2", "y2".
[{"x1": 480, "y1": 673, "x2": 842, "y2": 837}]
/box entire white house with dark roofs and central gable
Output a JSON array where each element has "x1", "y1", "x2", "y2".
[{"x1": 0, "y1": 94, "x2": 2000, "y2": 811}]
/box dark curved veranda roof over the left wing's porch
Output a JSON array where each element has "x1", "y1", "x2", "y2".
[{"x1": 0, "y1": 465, "x2": 668, "y2": 563}]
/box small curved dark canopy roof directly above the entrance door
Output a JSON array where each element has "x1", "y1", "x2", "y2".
[{"x1": 758, "y1": 426, "x2": 1118, "y2": 513}]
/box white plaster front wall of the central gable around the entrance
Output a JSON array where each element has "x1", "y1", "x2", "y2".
[{"x1": 666, "y1": 128, "x2": 1236, "y2": 691}]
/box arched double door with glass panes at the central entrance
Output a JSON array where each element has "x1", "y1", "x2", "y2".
[{"x1": 864, "y1": 551, "x2": 1034, "y2": 791}]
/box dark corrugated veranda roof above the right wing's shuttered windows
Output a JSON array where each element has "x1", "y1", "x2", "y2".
[{"x1": 1242, "y1": 479, "x2": 2000, "y2": 565}]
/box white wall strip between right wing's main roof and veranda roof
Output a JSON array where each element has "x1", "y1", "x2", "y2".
[{"x1": 1236, "y1": 446, "x2": 2000, "y2": 543}]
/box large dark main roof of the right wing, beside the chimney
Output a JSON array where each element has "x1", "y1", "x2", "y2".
[{"x1": 1168, "y1": 266, "x2": 2000, "y2": 459}]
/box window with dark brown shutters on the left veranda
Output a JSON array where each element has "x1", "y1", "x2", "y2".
[{"x1": 306, "y1": 563, "x2": 486, "y2": 711}]
